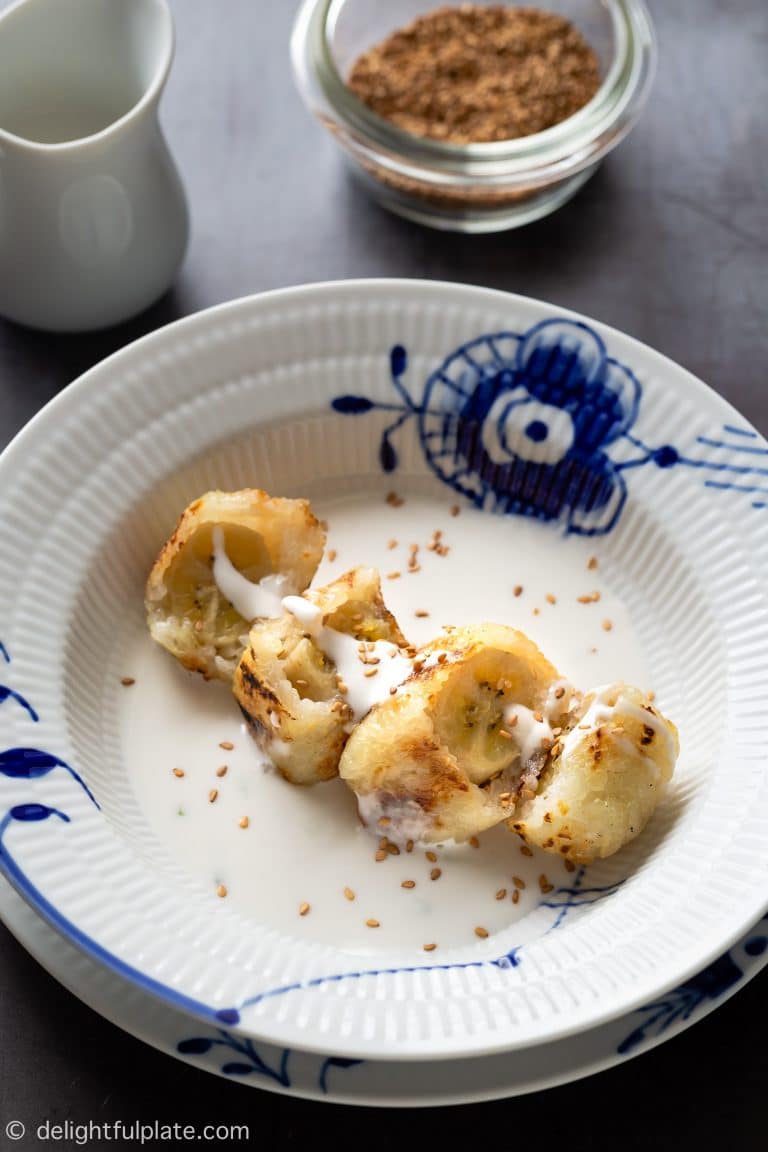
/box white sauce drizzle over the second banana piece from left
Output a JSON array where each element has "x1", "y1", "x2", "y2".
[{"x1": 282, "y1": 596, "x2": 413, "y2": 723}]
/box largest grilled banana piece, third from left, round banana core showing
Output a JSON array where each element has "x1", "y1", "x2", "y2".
[{"x1": 340, "y1": 624, "x2": 572, "y2": 843}]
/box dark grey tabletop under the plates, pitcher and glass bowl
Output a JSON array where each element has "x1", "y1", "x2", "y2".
[{"x1": 0, "y1": 0, "x2": 768, "y2": 1152}]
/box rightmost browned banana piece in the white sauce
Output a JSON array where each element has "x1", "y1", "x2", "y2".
[{"x1": 509, "y1": 683, "x2": 679, "y2": 864}]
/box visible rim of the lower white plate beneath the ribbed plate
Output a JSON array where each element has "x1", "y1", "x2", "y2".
[{"x1": 0, "y1": 879, "x2": 768, "y2": 1108}]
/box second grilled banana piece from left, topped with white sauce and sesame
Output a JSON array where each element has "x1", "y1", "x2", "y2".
[{"x1": 233, "y1": 568, "x2": 411, "y2": 785}]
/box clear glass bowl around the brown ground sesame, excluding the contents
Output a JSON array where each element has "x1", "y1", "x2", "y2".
[{"x1": 291, "y1": 0, "x2": 656, "y2": 233}]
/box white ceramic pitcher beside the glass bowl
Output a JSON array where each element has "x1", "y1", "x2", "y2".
[{"x1": 0, "y1": 0, "x2": 189, "y2": 332}]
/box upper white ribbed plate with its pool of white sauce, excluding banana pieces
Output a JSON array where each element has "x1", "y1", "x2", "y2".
[{"x1": 0, "y1": 281, "x2": 768, "y2": 1059}]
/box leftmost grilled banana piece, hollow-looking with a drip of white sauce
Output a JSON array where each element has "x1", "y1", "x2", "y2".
[{"x1": 144, "y1": 488, "x2": 325, "y2": 681}]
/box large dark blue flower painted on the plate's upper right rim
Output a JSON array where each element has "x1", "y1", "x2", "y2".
[{"x1": 332, "y1": 319, "x2": 768, "y2": 536}]
